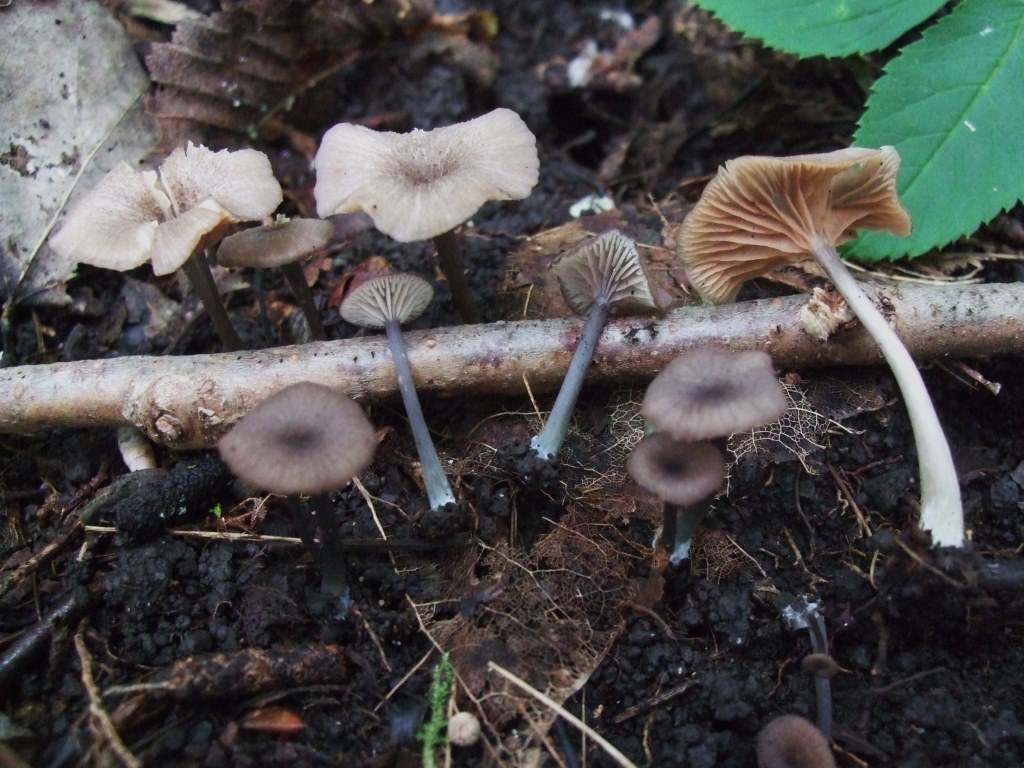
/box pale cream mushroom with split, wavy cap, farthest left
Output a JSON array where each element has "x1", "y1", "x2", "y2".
[{"x1": 50, "y1": 141, "x2": 283, "y2": 351}]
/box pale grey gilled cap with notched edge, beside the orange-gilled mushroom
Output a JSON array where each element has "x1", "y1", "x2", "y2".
[{"x1": 554, "y1": 229, "x2": 658, "y2": 314}]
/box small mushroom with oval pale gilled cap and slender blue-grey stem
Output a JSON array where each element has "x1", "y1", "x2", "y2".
[{"x1": 341, "y1": 274, "x2": 456, "y2": 510}]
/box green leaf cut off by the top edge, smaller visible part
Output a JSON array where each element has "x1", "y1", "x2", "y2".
[{"x1": 694, "y1": 0, "x2": 945, "y2": 56}]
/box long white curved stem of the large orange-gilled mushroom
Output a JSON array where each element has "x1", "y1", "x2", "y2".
[{"x1": 812, "y1": 238, "x2": 964, "y2": 547}]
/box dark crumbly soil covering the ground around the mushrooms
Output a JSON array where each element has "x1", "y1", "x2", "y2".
[{"x1": 0, "y1": 0, "x2": 1024, "y2": 768}]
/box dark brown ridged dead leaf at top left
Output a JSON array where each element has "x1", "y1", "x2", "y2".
[{"x1": 145, "y1": 0, "x2": 432, "y2": 147}]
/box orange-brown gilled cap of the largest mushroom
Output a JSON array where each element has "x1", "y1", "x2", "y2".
[{"x1": 677, "y1": 146, "x2": 910, "y2": 302}]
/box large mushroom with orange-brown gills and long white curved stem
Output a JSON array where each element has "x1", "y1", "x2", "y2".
[{"x1": 677, "y1": 146, "x2": 964, "y2": 547}]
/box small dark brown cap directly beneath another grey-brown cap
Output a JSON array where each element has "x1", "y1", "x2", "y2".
[{"x1": 626, "y1": 432, "x2": 725, "y2": 507}]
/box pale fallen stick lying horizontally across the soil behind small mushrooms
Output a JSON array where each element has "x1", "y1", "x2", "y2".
[{"x1": 0, "y1": 284, "x2": 1024, "y2": 449}]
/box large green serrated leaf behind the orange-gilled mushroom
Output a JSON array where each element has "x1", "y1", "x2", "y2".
[{"x1": 850, "y1": 0, "x2": 1024, "y2": 260}]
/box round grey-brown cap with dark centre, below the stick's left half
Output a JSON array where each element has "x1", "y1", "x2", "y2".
[{"x1": 217, "y1": 382, "x2": 377, "y2": 494}]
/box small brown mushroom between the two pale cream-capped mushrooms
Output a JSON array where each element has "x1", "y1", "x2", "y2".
[{"x1": 217, "y1": 216, "x2": 334, "y2": 341}]
